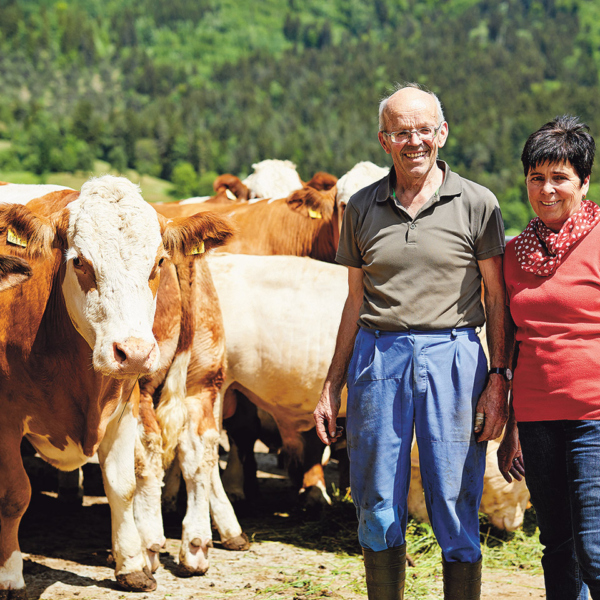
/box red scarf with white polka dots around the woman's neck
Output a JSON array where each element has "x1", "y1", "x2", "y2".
[{"x1": 515, "y1": 200, "x2": 600, "y2": 277}]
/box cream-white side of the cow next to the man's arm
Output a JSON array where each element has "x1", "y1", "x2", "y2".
[{"x1": 208, "y1": 254, "x2": 348, "y2": 422}]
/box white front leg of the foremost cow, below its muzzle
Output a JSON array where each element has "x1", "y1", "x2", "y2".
[{"x1": 98, "y1": 401, "x2": 156, "y2": 591}]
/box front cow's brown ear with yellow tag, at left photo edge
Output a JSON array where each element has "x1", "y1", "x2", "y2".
[{"x1": 0, "y1": 204, "x2": 55, "y2": 258}]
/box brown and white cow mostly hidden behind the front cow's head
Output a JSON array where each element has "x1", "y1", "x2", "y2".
[{"x1": 135, "y1": 233, "x2": 249, "y2": 575}]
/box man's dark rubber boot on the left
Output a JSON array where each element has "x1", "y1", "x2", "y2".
[{"x1": 363, "y1": 544, "x2": 406, "y2": 600}]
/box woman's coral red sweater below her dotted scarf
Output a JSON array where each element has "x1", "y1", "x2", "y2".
[{"x1": 504, "y1": 225, "x2": 600, "y2": 421}]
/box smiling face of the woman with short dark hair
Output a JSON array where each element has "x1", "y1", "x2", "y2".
[{"x1": 526, "y1": 161, "x2": 590, "y2": 231}]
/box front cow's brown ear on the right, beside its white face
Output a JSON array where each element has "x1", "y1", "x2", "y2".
[{"x1": 158, "y1": 212, "x2": 235, "y2": 260}]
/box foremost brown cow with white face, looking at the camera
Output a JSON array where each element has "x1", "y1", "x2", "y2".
[{"x1": 0, "y1": 176, "x2": 239, "y2": 600}]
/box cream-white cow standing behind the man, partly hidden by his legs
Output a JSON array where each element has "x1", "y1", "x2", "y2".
[{"x1": 208, "y1": 254, "x2": 529, "y2": 530}]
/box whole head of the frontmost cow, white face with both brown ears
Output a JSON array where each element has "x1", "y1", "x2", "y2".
[{"x1": 4, "y1": 175, "x2": 232, "y2": 378}]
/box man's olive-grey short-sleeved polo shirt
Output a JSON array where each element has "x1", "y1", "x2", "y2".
[{"x1": 336, "y1": 161, "x2": 505, "y2": 331}]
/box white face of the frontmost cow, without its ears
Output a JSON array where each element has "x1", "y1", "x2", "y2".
[{"x1": 62, "y1": 176, "x2": 168, "y2": 375}]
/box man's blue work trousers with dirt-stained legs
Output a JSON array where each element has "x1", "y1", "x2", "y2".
[{"x1": 346, "y1": 328, "x2": 487, "y2": 563}]
